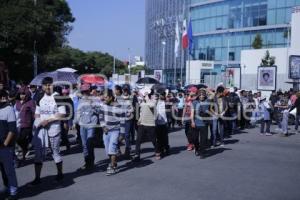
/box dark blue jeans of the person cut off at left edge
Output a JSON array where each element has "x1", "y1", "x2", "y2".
[{"x1": 0, "y1": 147, "x2": 18, "y2": 195}]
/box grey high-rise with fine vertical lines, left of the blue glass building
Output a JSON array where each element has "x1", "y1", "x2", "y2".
[{"x1": 145, "y1": 0, "x2": 185, "y2": 83}]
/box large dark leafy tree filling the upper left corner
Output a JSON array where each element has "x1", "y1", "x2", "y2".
[{"x1": 0, "y1": 0, "x2": 75, "y2": 79}]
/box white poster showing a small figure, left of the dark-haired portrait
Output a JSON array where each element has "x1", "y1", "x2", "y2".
[{"x1": 225, "y1": 67, "x2": 241, "y2": 89}]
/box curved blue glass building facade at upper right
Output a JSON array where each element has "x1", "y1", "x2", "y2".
[{"x1": 146, "y1": 0, "x2": 300, "y2": 84}]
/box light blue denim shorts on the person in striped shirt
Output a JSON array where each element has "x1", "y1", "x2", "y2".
[{"x1": 103, "y1": 130, "x2": 120, "y2": 156}]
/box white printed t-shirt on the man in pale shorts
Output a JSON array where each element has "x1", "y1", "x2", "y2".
[{"x1": 35, "y1": 94, "x2": 66, "y2": 137}]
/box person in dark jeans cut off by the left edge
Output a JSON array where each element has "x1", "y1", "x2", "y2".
[{"x1": 0, "y1": 90, "x2": 18, "y2": 200}]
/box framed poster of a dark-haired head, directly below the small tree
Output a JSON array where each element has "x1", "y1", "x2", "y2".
[{"x1": 257, "y1": 66, "x2": 277, "y2": 91}]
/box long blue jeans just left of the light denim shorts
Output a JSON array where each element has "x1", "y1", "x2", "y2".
[{"x1": 80, "y1": 127, "x2": 95, "y2": 164}]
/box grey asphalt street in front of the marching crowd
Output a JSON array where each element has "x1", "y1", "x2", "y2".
[{"x1": 0, "y1": 128, "x2": 300, "y2": 200}]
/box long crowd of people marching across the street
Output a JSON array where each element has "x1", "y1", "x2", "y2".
[{"x1": 0, "y1": 77, "x2": 300, "y2": 199}]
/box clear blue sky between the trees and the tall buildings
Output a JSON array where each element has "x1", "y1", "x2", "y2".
[{"x1": 67, "y1": 0, "x2": 145, "y2": 60}]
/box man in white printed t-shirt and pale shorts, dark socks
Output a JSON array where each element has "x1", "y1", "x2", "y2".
[{"x1": 30, "y1": 77, "x2": 66, "y2": 186}]
